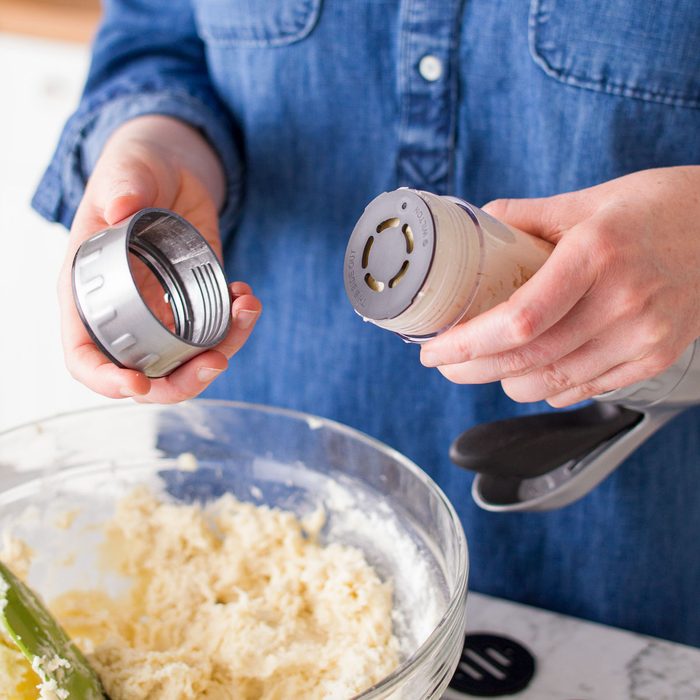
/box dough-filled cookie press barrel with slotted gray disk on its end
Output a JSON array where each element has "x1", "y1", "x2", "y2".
[{"x1": 344, "y1": 188, "x2": 552, "y2": 342}]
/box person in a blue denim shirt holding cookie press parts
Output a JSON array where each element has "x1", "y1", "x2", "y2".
[{"x1": 34, "y1": 0, "x2": 700, "y2": 645}]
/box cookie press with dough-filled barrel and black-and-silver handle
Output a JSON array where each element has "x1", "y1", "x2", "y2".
[{"x1": 344, "y1": 188, "x2": 700, "y2": 512}]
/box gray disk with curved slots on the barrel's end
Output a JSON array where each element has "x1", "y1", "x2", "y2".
[{"x1": 343, "y1": 188, "x2": 435, "y2": 321}]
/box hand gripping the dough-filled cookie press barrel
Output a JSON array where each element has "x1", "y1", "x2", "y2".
[{"x1": 421, "y1": 166, "x2": 700, "y2": 407}]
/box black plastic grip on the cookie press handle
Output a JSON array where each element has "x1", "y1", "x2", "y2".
[{"x1": 450, "y1": 402, "x2": 644, "y2": 479}]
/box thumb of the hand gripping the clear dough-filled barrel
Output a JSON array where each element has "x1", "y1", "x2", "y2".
[{"x1": 482, "y1": 194, "x2": 582, "y2": 243}]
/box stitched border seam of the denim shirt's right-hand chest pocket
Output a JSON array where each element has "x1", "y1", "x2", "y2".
[{"x1": 528, "y1": 0, "x2": 700, "y2": 108}]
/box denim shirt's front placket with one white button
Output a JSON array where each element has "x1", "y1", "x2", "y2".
[{"x1": 397, "y1": 0, "x2": 462, "y2": 194}]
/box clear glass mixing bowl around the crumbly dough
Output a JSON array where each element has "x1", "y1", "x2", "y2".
[{"x1": 0, "y1": 401, "x2": 468, "y2": 700}]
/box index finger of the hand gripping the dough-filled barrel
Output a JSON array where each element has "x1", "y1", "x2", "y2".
[{"x1": 421, "y1": 239, "x2": 594, "y2": 367}]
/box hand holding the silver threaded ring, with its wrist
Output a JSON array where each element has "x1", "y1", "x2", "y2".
[{"x1": 58, "y1": 115, "x2": 262, "y2": 403}]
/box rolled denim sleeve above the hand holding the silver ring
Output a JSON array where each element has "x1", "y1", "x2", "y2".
[{"x1": 32, "y1": 0, "x2": 243, "y2": 236}]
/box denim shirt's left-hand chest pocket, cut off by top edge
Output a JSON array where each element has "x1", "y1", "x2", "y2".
[{"x1": 192, "y1": 0, "x2": 322, "y2": 47}]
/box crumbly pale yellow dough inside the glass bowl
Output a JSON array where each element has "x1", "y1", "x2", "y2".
[{"x1": 51, "y1": 488, "x2": 399, "y2": 700}]
